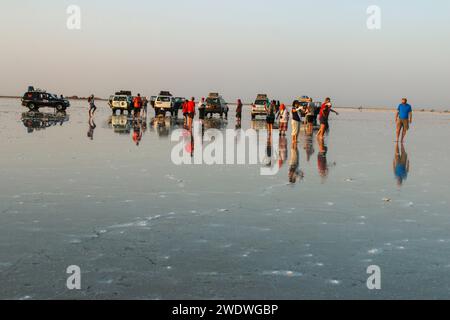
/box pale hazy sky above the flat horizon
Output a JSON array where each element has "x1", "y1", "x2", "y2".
[{"x1": 0, "y1": 0, "x2": 450, "y2": 108}]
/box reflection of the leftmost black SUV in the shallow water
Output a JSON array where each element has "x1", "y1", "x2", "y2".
[{"x1": 22, "y1": 111, "x2": 69, "y2": 133}]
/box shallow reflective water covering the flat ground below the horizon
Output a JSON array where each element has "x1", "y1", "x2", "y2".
[{"x1": 0, "y1": 99, "x2": 450, "y2": 299}]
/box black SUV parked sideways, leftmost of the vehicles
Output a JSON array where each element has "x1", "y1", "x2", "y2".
[{"x1": 22, "y1": 88, "x2": 70, "y2": 111}]
